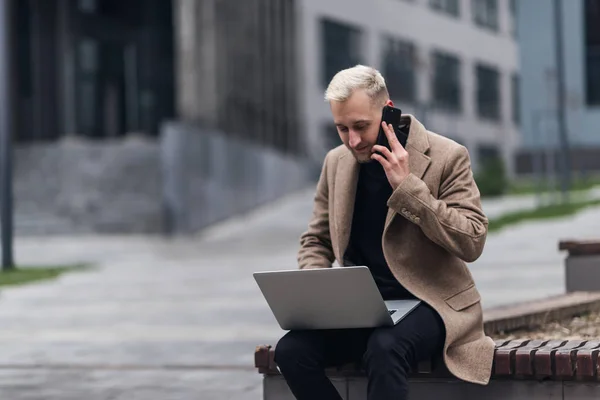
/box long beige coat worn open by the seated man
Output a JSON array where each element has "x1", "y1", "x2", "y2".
[{"x1": 298, "y1": 115, "x2": 494, "y2": 384}]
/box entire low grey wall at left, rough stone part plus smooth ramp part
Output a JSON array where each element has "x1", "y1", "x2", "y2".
[{"x1": 14, "y1": 123, "x2": 314, "y2": 235}]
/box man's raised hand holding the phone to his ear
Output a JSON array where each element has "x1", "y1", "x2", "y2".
[{"x1": 371, "y1": 121, "x2": 410, "y2": 190}]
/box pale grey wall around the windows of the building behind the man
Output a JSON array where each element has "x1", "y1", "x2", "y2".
[{"x1": 298, "y1": 0, "x2": 520, "y2": 171}]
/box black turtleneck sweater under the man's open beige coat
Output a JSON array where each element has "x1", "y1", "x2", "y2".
[{"x1": 346, "y1": 161, "x2": 414, "y2": 300}]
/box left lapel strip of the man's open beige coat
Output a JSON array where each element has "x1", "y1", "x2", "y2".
[{"x1": 334, "y1": 152, "x2": 359, "y2": 263}]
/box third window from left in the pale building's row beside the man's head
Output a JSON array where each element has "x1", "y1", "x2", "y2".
[{"x1": 433, "y1": 51, "x2": 462, "y2": 111}]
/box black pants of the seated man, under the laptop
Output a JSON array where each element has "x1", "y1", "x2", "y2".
[{"x1": 275, "y1": 303, "x2": 446, "y2": 400}]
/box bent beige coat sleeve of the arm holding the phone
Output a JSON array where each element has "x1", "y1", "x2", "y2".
[{"x1": 388, "y1": 146, "x2": 488, "y2": 262}]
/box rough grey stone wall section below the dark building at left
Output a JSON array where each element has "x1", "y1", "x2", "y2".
[{"x1": 14, "y1": 136, "x2": 162, "y2": 234}]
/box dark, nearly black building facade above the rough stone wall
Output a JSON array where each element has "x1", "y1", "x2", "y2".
[{"x1": 12, "y1": 0, "x2": 175, "y2": 142}]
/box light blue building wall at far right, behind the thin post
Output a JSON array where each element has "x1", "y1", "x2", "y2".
[{"x1": 517, "y1": 0, "x2": 600, "y2": 148}]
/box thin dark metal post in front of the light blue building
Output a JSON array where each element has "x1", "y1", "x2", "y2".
[{"x1": 554, "y1": 0, "x2": 571, "y2": 203}]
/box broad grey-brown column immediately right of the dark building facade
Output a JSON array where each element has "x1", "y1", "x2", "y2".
[{"x1": 173, "y1": 0, "x2": 218, "y2": 127}]
